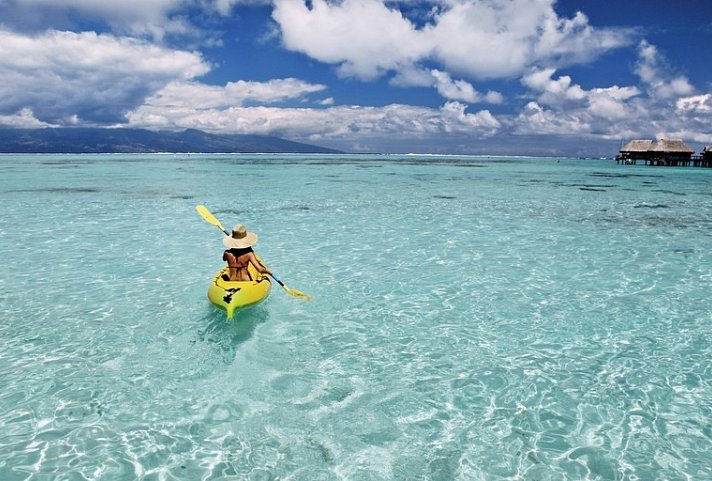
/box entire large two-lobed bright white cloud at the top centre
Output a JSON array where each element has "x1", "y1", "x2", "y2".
[{"x1": 273, "y1": 0, "x2": 631, "y2": 80}]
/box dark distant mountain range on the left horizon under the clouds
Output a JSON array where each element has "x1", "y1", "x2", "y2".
[{"x1": 0, "y1": 127, "x2": 341, "y2": 154}]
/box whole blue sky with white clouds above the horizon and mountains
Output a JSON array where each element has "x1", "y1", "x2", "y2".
[{"x1": 0, "y1": 0, "x2": 712, "y2": 156}]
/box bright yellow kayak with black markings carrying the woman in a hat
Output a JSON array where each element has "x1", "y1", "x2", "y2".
[{"x1": 208, "y1": 264, "x2": 272, "y2": 319}]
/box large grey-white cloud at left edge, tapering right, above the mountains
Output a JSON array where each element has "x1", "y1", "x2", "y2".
[{"x1": 0, "y1": 30, "x2": 210, "y2": 125}]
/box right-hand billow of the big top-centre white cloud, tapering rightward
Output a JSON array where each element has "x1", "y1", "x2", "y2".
[{"x1": 432, "y1": 0, "x2": 629, "y2": 79}]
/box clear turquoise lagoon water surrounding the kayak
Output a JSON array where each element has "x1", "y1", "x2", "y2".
[{"x1": 0, "y1": 155, "x2": 712, "y2": 481}]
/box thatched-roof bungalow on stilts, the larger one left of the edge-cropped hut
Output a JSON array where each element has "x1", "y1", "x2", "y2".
[{"x1": 616, "y1": 139, "x2": 697, "y2": 167}]
